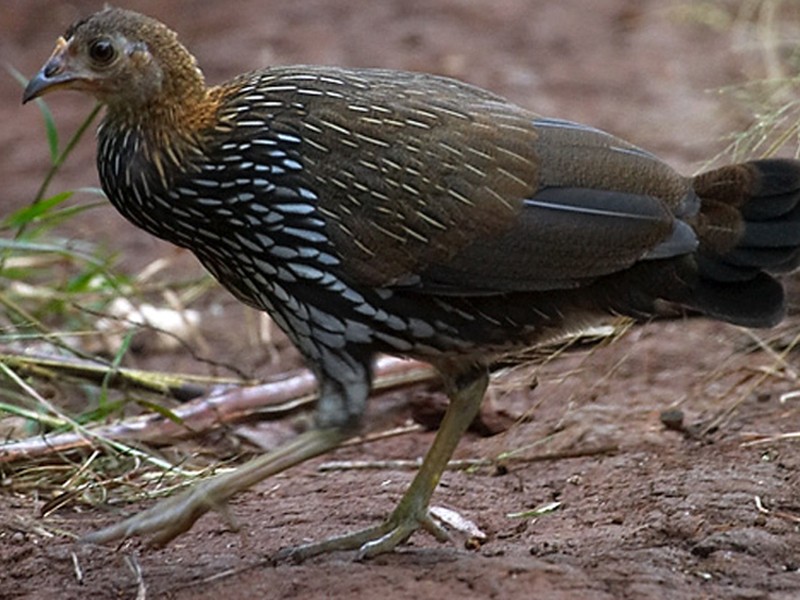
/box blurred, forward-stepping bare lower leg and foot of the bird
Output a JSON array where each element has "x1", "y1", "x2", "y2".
[{"x1": 83, "y1": 427, "x2": 350, "y2": 545}]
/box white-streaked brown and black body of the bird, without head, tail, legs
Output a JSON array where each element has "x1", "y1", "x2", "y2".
[{"x1": 99, "y1": 67, "x2": 800, "y2": 355}]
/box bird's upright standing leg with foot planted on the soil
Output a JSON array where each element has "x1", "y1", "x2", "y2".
[{"x1": 284, "y1": 368, "x2": 489, "y2": 560}]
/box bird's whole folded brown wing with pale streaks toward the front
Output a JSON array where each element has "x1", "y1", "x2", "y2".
[{"x1": 239, "y1": 68, "x2": 696, "y2": 295}]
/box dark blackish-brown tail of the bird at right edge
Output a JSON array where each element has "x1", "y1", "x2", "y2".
[{"x1": 687, "y1": 159, "x2": 800, "y2": 327}]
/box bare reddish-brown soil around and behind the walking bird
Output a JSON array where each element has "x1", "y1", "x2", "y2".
[{"x1": 0, "y1": 0, "x2": 800, "y2": 600}]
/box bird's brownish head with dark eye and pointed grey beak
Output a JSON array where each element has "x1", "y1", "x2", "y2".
[{"x1": 23, "y1": 8, "x2": 204, "y2": 111}]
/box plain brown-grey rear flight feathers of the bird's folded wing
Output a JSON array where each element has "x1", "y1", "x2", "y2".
[{"x1": 394, "y1": 119, "x2": 698, "y2": 294}]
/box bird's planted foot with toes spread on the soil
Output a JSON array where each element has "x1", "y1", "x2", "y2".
[{"x1": 275, "y1": 504, "x2": 450, "y2": 562}]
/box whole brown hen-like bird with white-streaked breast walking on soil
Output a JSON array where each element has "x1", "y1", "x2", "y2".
[{"x1": 23, "y1": 7, "x2": 800, "y2": 560}]
